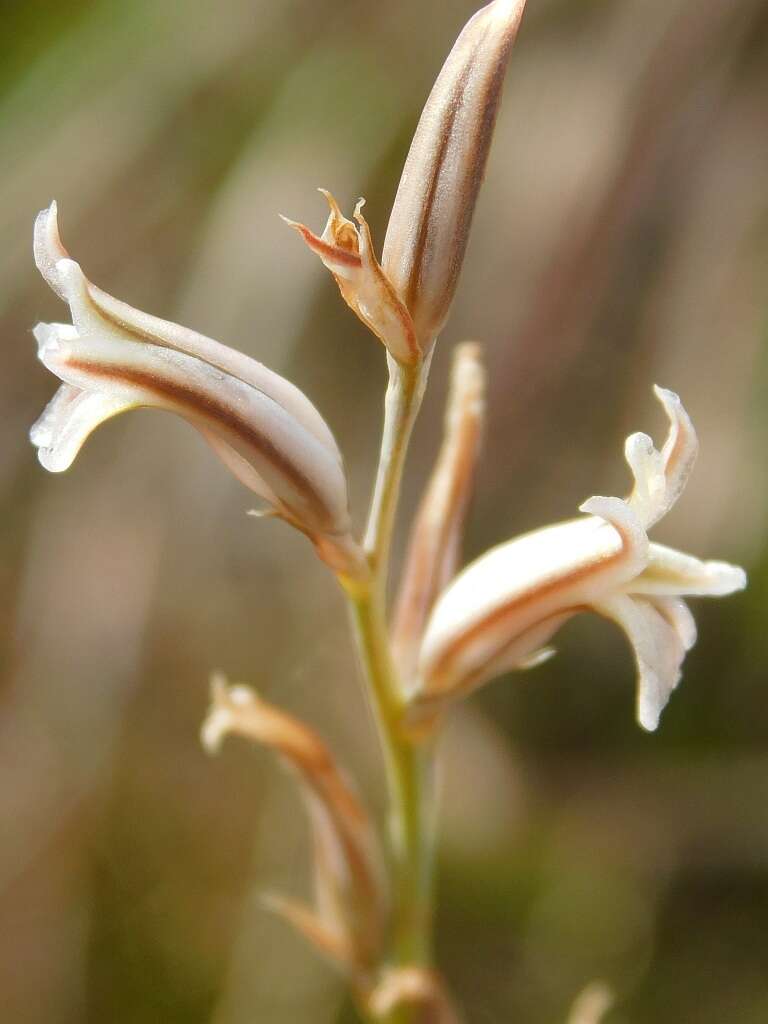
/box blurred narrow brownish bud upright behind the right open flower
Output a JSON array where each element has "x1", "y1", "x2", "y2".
[{"x1": 392, "y1": 342, "x2": 485, "y2": 678}]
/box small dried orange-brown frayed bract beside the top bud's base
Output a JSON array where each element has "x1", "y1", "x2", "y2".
[{"x1": 283, "y1": 188, "x2": 420, "y2": 365}]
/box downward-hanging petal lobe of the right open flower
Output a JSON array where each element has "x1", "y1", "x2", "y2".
[{"x1": 593, "y1": 594, "x2": 685, "y2": 731}]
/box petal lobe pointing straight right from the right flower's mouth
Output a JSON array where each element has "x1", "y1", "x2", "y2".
[{"x1": 626, "y1": 543, "x2": 746, "y2": 597}]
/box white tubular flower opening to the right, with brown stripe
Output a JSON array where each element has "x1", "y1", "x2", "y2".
[{"x1": 410, "y1": 388, "x2": 746, "y2": 730}]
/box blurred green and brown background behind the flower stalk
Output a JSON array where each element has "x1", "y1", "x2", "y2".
[{"x1": 0, "y1": 0, "x2": 768, "y2": 1024}]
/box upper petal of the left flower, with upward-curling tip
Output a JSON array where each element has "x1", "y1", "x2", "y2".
[{"x1": 34, "y1": 203, "x2": 340, "y2": 459}]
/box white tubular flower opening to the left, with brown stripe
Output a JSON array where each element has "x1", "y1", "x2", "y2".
[{"x1": 31, "y1": 203, "x2": 360, "y2": 572}]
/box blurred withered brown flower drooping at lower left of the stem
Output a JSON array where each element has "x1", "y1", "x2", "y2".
[{"x1": 202, "y1": 676, "x2": 385, "y2": 988}]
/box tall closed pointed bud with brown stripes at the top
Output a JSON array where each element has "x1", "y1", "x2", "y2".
[{"x1": 382, "y1": 0, "x2": 525, "y2": 351}]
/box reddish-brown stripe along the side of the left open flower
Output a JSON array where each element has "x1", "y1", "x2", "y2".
[{"x1": 68, "y1": 358, "x2": 342, "y2": 531}]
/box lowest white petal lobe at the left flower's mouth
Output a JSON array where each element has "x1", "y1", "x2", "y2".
[{"x1": 30, "y1": 384, "x2": 135, "y2": 473}]
